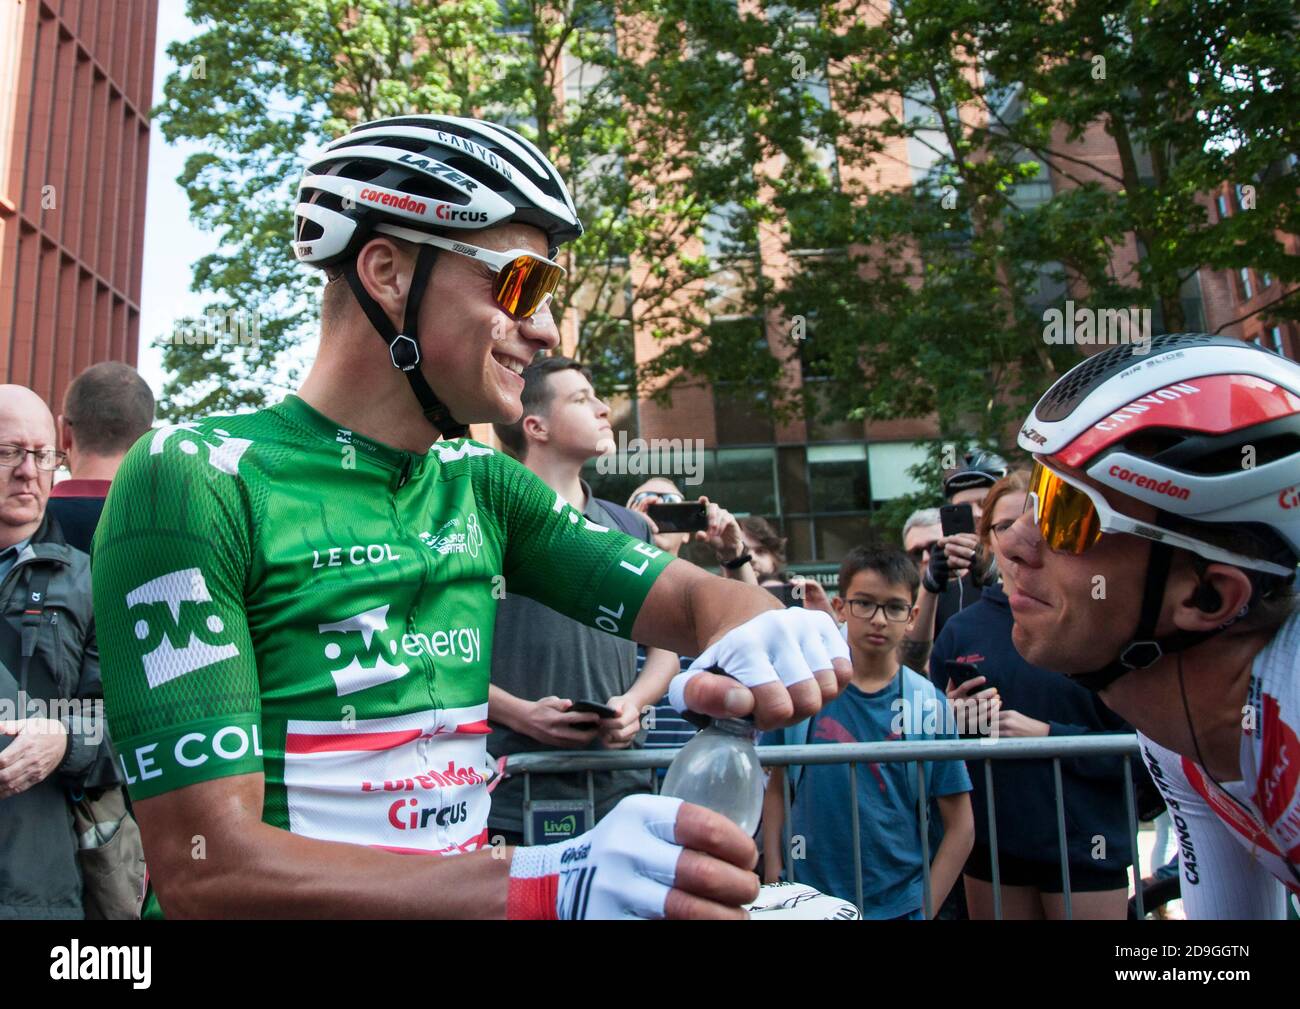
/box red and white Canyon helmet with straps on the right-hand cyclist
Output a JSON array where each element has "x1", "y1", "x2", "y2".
[{"x1": 1019, "y1": 333, "x2": 1300, "y2": 689}]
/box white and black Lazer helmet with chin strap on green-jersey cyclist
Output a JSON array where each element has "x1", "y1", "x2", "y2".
[{"x1": 294, "y1": 116, "x2": 582, "y2": 437}]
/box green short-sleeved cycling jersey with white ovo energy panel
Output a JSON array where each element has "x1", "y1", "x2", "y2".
[{"x1": 94, "y1": 397, "x2": 671, "y2": 854}]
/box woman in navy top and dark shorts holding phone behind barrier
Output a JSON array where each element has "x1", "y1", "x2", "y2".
[{"x1": 931, "y1": 471, "x2": 1132, "y2": 921}]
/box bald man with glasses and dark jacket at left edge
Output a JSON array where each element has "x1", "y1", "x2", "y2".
[{"x1": 0, "y1": 385, "x2": 117, "y2": 918}]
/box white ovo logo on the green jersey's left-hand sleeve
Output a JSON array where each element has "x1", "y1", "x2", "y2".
[{"x1": 126, "y1": 568, "x2": 239, "y2": 689}]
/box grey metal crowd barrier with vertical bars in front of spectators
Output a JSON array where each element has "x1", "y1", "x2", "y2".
[{"x1": 506, "y1": 733, "x2": 1154, "y2": 921}]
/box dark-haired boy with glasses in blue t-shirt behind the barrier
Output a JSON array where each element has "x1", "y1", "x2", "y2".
[{"x1": 763, "y1": 546, "x2": 975, "y2": 919}]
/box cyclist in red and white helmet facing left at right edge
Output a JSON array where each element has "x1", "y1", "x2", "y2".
[{"x1": 998, "y1": 334, "x2": 1300, "y2": 918}]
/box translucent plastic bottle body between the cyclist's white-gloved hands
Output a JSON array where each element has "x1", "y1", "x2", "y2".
[{"x1": 660, "y1": 718, "x2": 763, "y2": 835}]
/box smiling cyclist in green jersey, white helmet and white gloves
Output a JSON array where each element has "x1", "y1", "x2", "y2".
[{"x1": 94, "y1": 116, "x2": 850, "y2": 918}]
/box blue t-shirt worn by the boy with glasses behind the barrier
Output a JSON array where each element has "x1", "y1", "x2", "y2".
[{"x1": 762, "y1": 667, "x2": 971, "y2": 918}]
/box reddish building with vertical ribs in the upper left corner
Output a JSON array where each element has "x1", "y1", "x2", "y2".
[{"x1": 0, "y1": 0, "x2": 159, "y2": 413}]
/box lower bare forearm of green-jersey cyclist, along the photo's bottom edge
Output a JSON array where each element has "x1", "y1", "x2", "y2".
[{"x1": 156, "y1": 822, "x2": 514, "y2": 918}]
